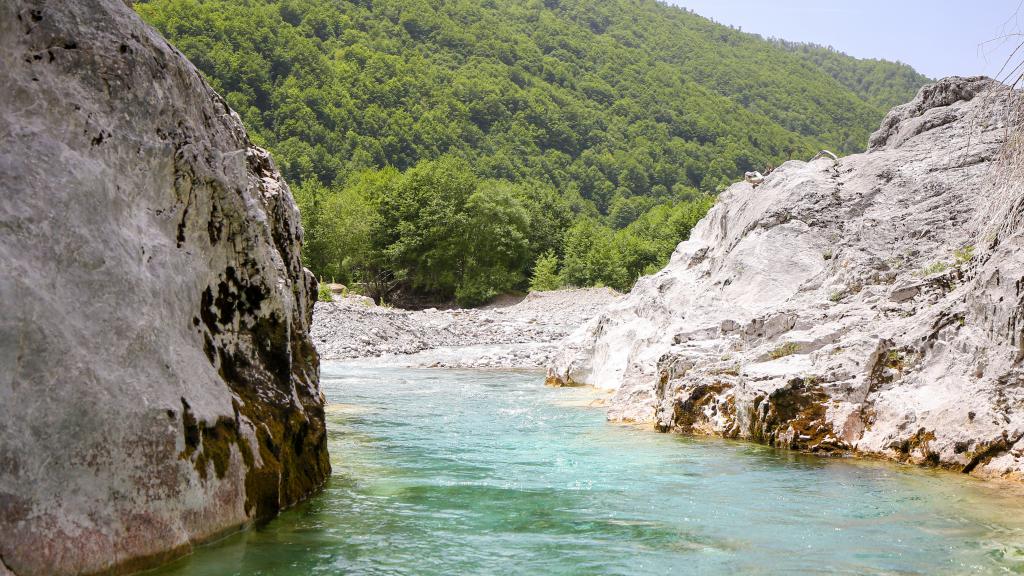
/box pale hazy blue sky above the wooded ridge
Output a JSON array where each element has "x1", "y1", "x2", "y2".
[{"x1": 668, "y1": 0, "x2": 1024, "y2": 78}]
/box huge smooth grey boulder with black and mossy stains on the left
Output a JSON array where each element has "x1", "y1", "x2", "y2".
[{"x1": 0, "y1": 0, "x2": 330, "y2": 576}]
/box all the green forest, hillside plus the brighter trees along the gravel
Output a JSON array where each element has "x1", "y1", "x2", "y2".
[{"x1": 134, "y1": 0, "x2": 928, "y2": 305}]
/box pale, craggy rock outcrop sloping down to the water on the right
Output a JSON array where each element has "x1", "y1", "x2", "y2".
[{"x1": 549, "y1": 78, "x2": 1024, "y2": 478}]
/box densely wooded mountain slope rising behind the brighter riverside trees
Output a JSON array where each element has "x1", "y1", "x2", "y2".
[{"x1": 137, "y1": 0, "x2": 920, "y2": 194}]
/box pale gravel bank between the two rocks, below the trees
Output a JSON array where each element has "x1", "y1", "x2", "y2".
[{"x1": 312, "y1": 288, "x2": 622, "y2": 369}]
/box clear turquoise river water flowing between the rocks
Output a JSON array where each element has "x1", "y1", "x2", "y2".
[{"x1": 151, "y1": 363, "x2": 1024, "y2": 576}]
